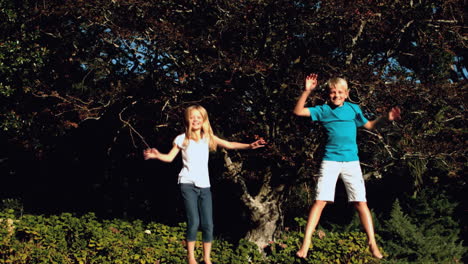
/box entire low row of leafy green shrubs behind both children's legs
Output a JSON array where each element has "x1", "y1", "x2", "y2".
[{"x1": 0, "y1": 210, "x2": 376, "y2": 264}]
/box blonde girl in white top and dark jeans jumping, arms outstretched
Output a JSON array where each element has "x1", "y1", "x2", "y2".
[{"x1": 143, "y1": 105, "x2": 265, "y2": 264}]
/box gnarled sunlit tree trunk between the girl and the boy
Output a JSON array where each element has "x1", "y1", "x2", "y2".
[{"x1": 223, "y1": 151, "x2": 282, "y2": 251}]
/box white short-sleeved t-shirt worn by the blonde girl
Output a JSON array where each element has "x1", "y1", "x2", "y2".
[{"x1": 174, "y1": 134, "x2": 210, "y2": 188}]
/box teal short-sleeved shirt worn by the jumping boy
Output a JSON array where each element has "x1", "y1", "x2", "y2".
[{"x1": 309, "y1": 102, "x2": 368, "y2": 161}]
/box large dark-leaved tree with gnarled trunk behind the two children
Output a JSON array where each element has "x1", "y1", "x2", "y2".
[{"x1": 0, "y1": 0, "x2": 467, "y2": 250}]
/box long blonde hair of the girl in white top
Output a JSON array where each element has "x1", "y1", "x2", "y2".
[{"x1": 183, "y1": 105, "x2": 216, "y2": 151}]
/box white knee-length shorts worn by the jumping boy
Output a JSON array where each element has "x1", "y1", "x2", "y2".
[{"x1": 315, "y1": 160, "x2": 367, "y2": 202}]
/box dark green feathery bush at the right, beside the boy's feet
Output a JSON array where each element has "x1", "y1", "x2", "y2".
[{"x1": 381, "y1": 190, "x2": 467, "y2": 264}]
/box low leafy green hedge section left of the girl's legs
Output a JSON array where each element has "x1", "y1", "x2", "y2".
[{"x1": 0, "y1": 213, "x2": 190, "y2": 264}]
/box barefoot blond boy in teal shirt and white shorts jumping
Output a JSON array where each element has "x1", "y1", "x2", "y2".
[{"x1": 294, "y1": 74, "x2": 400, "y2": 259}]
